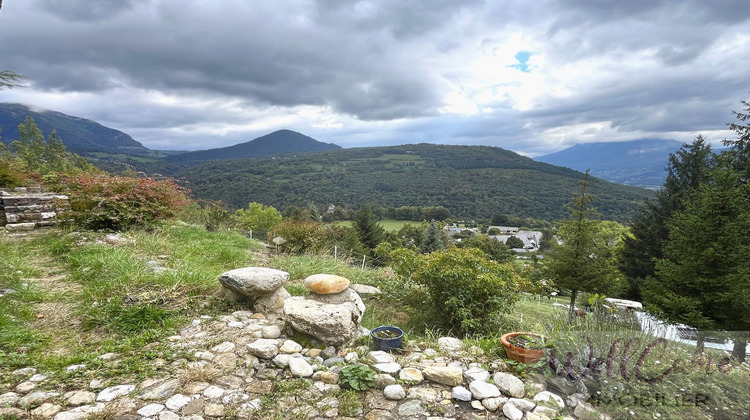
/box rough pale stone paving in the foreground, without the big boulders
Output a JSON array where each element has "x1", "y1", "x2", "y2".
[{"x1": 0, "y1": 311, "x2": 605, "y2": 420}]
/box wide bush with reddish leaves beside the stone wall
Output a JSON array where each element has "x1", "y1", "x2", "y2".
[{"x1": 62, "y1": 173, "x2": 189, "y2": 230}]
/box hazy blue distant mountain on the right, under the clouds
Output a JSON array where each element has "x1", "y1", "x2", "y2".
[{"x1": 535, "y1": 139, "x2": 682, "y2": 189}]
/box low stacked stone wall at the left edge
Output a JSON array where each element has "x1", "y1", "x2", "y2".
[{"x1": 0, "y1": 187, "x2": 70, "y2": 232}]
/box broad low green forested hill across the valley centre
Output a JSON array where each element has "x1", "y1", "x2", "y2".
[{"x1": 180, "y1": 144, "x2": 651, "y2": 221}]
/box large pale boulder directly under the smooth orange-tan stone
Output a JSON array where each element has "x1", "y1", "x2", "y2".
[{"x1": 284, "y1": 295, "x2": 364, "y2": 346}]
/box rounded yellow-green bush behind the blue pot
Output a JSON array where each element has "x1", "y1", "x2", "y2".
[{"x1": 392, "y1": 248, "x2": 520, "y2": 334}]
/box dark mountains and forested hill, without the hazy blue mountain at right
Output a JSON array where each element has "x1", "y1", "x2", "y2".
[{"x1": 0, "y1": 104, "x2": 651, "y2": 221}]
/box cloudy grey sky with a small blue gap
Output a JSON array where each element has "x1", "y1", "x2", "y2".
[{"x1": 0, "y1": 0, "x2": 750, "y2": 156}]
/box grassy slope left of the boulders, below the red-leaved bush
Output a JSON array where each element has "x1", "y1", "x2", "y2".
[{"x1": 0, "y1": 224, "x2": 264, "y2": 393}]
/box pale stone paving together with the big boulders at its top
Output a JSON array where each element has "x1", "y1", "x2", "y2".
[{"x1": 0, "y1": 267, "x2": 606, "y2": 420}]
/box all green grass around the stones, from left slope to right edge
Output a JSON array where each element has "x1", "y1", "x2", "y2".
[{"x1": 0, "y1": 223, "x2": 750, "y2": 419}]
